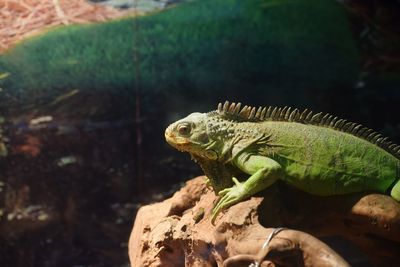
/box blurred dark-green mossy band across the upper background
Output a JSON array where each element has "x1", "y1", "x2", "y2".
[{"x1": 0, "y1": 0, "x2": 359, "y2": 107}]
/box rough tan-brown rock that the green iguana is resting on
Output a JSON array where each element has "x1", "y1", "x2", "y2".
[{"x1": 129, "y1": 177, "x2": 400, "y2": 267}]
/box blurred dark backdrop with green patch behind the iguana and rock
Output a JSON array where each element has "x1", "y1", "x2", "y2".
[{"x1": 0, "y1": 0, "x2": 400, "y2": 267}]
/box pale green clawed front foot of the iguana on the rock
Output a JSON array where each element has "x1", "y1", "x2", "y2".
[{"x1": 211, "y1": 177, "x2": 247, "y2": 224}]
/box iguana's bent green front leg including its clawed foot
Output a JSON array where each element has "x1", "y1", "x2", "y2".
[{"x1": 211, "y1": 153, "x2": 282, "y2": 223}]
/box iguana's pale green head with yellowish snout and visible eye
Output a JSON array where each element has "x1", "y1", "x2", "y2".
[{"x1": 165, "y1": 113, "x2": 222, "y2": 160}]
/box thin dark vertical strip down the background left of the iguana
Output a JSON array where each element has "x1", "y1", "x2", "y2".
[{"x1": 133, "y1": 0, "x2": 144, "y2": 196}]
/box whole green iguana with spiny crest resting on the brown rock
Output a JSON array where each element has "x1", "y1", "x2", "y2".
[{"x1": 165, "y1": 102, "x2": 400, "y2": 222}]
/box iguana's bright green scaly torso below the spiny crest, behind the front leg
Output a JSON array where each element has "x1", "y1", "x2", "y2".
[{"x1": 248, "y1": 121, "x2": 400, "y2": 195}]
